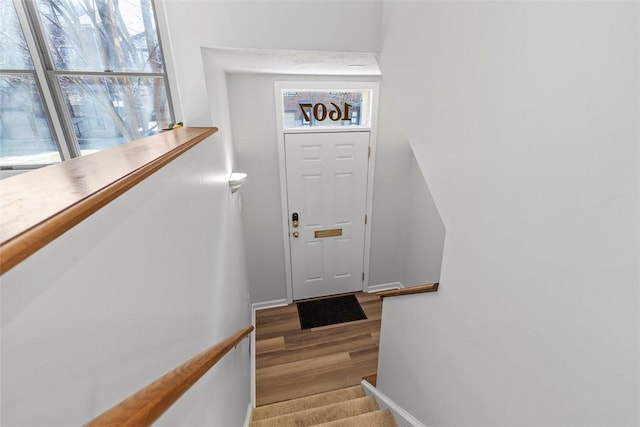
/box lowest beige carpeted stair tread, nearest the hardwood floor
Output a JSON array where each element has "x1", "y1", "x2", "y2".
[{"x1": 251, "y1": 385, "x2": 364, "y2": 421}]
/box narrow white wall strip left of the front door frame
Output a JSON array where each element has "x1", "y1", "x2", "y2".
[{"x1": 228, "y1": 74, "x2": 287, "y2": 302}]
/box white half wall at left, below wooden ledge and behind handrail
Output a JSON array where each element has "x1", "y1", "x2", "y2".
[{"x1": 0, "y1": 135, "x2": 251, "y2": 426}]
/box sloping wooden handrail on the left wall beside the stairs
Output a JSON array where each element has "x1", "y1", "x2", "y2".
[{"x1": 86, "y1": 325, "x2": 253, "y2": 427}]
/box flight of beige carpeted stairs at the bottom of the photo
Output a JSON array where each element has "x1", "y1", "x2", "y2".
[{"x1": 250, "y1": 385, "x2": 396, "y2": 427}]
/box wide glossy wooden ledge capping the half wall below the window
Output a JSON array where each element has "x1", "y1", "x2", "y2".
[{"x1": 0, "y1": 128, "x2": 218, "y2": 274}]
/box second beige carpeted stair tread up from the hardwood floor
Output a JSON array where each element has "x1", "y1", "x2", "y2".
[{"x1": 250, "y1": 396, "x2": 378, "y2": 427}]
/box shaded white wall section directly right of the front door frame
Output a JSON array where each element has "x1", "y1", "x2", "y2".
[{"x1": 369, "y1": 82, "x2": 445, "y2": 287}]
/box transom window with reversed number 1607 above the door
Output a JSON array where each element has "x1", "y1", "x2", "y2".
[{"x1": 282, "y1": 89, "x2": 372, "y2": 129}]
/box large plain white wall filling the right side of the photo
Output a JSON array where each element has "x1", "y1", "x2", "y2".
[{"x1": 378, "y1": 2, "x2": 640, "y2": 426}]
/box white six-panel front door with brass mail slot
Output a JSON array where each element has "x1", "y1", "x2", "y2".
[{"x1": 284, "y1": 132, "x2": 369, "y2": 300}]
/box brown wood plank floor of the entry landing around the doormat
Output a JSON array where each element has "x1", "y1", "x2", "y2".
[{"x1": 255, "y1": 292, "x2": 382, "y2": 406}]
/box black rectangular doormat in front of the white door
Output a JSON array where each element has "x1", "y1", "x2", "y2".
[{"x1": 296, "y1": 294, "x2": 367, "y2": 329}]
